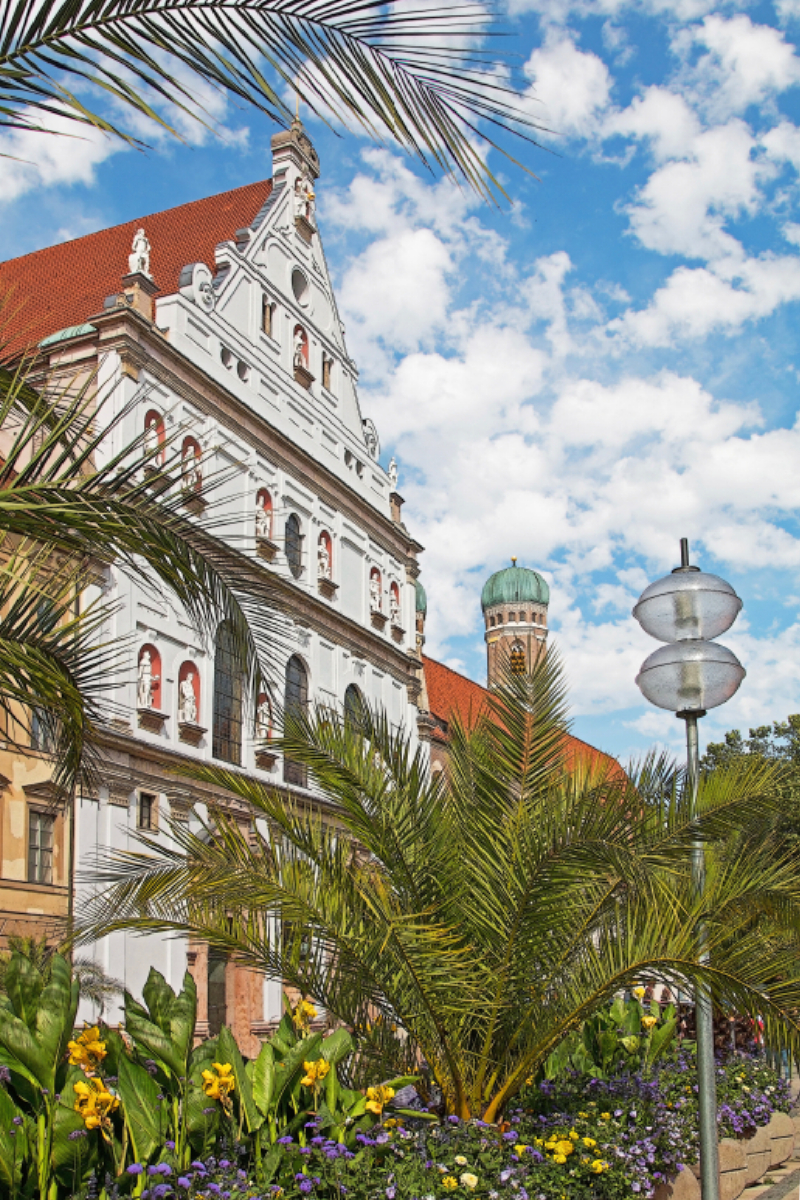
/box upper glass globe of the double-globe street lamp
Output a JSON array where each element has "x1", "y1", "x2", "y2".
[{"x1": 633, "y1": 570, "x2": 741, "y2": 642}]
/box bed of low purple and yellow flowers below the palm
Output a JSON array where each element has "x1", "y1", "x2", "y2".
[{"x1": 70, "y1": 1054, "x2": 789, "y2": 1200}]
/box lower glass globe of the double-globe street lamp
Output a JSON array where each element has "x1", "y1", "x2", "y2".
[{"x1": 636, "y1": 640, "x2": 746, "y2": 713}]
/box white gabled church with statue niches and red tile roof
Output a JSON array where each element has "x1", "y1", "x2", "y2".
[{"x1": 0, "y1": 121, "x2": 422, "y2": 1050}]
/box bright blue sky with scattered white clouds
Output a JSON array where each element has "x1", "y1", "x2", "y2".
[{"x1": 0, "y1": 0, "x2": 800, "y2": 757}]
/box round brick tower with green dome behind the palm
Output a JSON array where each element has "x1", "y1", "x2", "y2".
[{"x1": 481, "y1": 558, "x2": 551, "y2": 688}]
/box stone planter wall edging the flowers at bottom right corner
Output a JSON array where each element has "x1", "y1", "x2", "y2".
[{"x1": 655, "y1": 1112, "x2": 800, "y2": 1200}]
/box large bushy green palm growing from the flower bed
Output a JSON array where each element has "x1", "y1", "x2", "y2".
[{"x1": 73, "y1": 652, "x2": 800, "y2": 1121}]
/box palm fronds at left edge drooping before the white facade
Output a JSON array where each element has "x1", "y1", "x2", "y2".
[{"x1": 0, "y1": 350, "x2": 282, "y2": 800}]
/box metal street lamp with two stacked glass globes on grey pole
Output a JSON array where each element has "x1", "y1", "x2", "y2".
[{"x1": 633, "y1": 538, "x2": 745, "y2": 1200}]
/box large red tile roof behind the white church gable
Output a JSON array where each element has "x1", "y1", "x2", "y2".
[{"x1": 0, "y1": 179, "x2": 272, "y2": 353}]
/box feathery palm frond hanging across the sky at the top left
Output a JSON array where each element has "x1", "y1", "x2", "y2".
[{"x1": 0, "y1": 0, "x2": 537, "y2": 194}]
